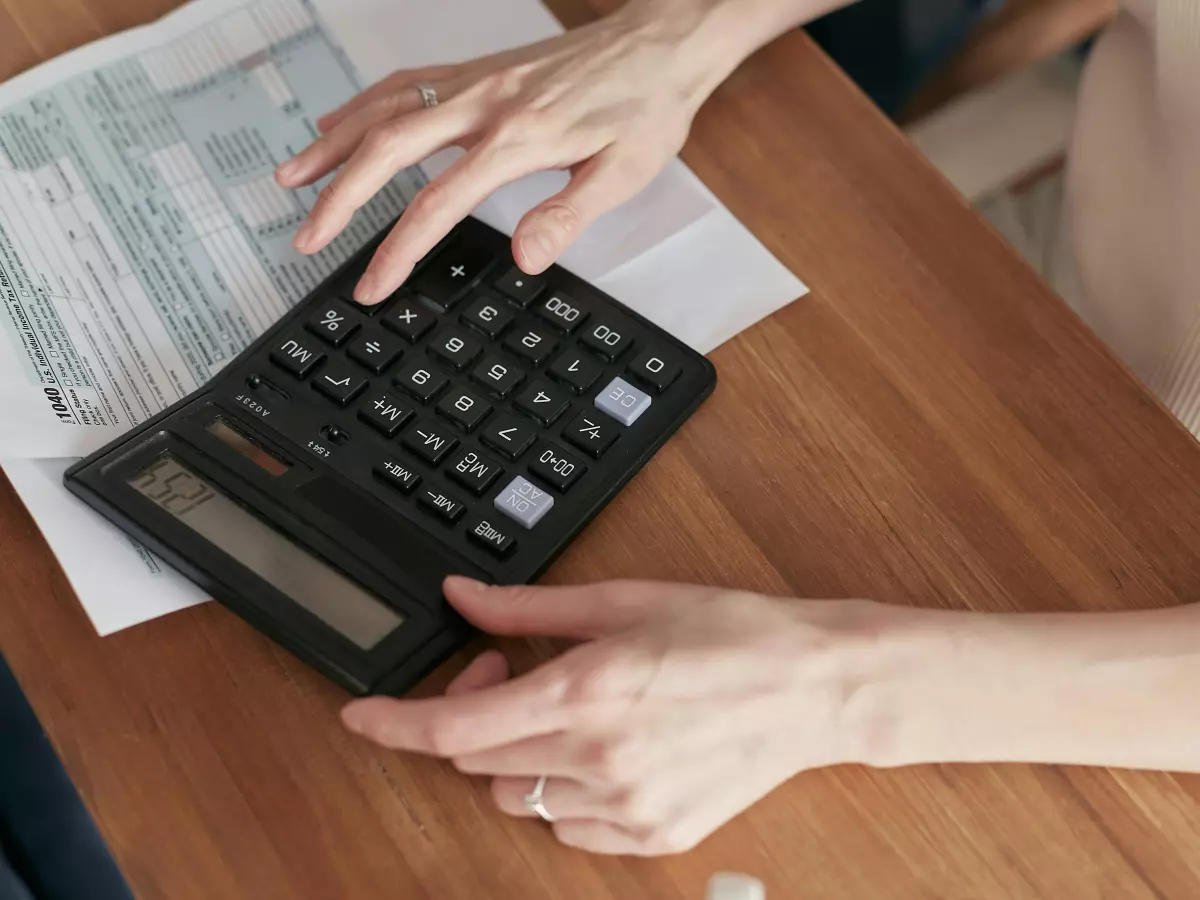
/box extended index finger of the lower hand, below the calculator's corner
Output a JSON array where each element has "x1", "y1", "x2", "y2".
[{"x1": 342, "y1": 662, "x2": 568, "y2": 758}]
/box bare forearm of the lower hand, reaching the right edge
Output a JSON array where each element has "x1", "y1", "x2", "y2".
[{"x1": 852, "y1": 607, "x2": 1200, "y2": 772}]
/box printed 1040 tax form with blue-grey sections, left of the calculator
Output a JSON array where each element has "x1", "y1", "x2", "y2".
[{"x1": 0, "y1": 0, "x2": 422, "y2": 457}]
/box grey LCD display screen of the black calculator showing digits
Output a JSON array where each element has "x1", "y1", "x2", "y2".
[{"x1": 130, "y1": 454, "x2": 404, "y2": 649}]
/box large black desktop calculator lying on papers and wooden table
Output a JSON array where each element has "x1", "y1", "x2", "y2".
[{"x1": 66, "y1": 218, "x2": 716, "y2": 694}]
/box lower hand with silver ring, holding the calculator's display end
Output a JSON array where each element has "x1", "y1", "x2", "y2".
[{"x1": 343, "y1": 577, "x2": 886, "y2": 856}]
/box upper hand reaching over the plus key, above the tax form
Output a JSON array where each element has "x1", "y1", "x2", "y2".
[{"x1": 277, "y1": 0, "x2": 777, "y2": 304}]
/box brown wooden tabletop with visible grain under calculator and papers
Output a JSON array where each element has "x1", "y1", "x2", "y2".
[{"x1": 7, "y1": 0, "x2": 1200, "y2": 900}]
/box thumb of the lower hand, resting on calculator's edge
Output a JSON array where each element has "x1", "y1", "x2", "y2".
[{"x1": 443, "y1": 575, "x2": 712, "y2": 640}]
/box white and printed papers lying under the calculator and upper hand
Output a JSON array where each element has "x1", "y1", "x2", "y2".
[{"x1": 0, "y1": 0, "x2": 805, "y2": 634}]
